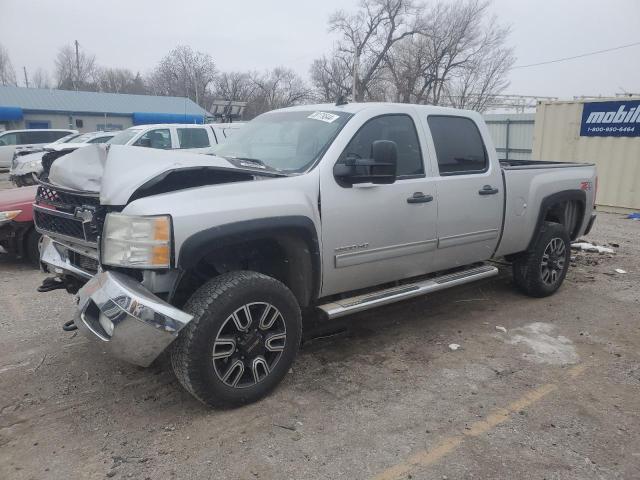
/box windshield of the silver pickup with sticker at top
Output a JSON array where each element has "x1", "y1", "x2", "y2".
[{"x1": 213, "y1": 110, "x2": 351, "y2": 173}]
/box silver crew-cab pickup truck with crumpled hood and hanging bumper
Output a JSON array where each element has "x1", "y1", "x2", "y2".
[{"x1": 34, "y1": 103, "x2": 596, "y2": 405}]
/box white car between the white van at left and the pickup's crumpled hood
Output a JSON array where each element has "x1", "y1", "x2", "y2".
[{"x1": 9, "y1": 131, "x2": 118, "y2": 187}]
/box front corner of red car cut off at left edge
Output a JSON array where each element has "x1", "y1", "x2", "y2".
[{"x1": 0, "y1": 186, "x2": 40, "y2": 265}]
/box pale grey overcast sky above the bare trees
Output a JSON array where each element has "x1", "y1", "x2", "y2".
[{"x1": 0, "y1": 0, "x2": 640, "y2": 98}]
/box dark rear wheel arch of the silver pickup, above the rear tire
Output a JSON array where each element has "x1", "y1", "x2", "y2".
[{"x1": 527, "y1": 190, "x2": 587, "y2": 251}]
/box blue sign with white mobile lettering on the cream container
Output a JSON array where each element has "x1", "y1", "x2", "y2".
[{"x1": 580, "y1": 100, "x2": 640, "y2": 137}]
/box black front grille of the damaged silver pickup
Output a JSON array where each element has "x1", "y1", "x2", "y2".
[{"x1": 33, "y1": 184, "x2": 105, "y2": 243}]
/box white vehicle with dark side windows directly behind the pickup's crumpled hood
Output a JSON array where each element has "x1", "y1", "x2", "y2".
[{"x1": 107, "y1": 123, "x2": 243, "y2": 153}]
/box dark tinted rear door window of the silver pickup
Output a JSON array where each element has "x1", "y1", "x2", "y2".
[{"x1": 427, "y1": 115, "x2": 488, "y2": 176}]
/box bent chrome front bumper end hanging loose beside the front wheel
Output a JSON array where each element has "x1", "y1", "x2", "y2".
[{"x1": 75, "y1": 272, "x2": 193, "y2": 367}]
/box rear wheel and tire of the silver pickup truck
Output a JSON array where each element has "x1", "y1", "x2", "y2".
[{"x1": 513, "y1": 222, "x2": 571, "y2": 297}]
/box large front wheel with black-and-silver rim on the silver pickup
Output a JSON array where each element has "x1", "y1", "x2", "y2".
[{"x1": 171, "y1": 271, "x2": 302, "y2": 407}]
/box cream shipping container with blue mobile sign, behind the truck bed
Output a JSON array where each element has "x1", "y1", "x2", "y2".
[{"x1": 532, "y1": 97, "x2": 640, "y2": 211}]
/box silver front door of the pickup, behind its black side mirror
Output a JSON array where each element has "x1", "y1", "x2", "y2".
[{"x1": 320, "y1": 111, "x2": 437, "y2": 296}]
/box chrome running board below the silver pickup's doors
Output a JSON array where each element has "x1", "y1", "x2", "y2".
[{"x1": 318, "y1": 265, "x2": 498, "y2": 319}]
